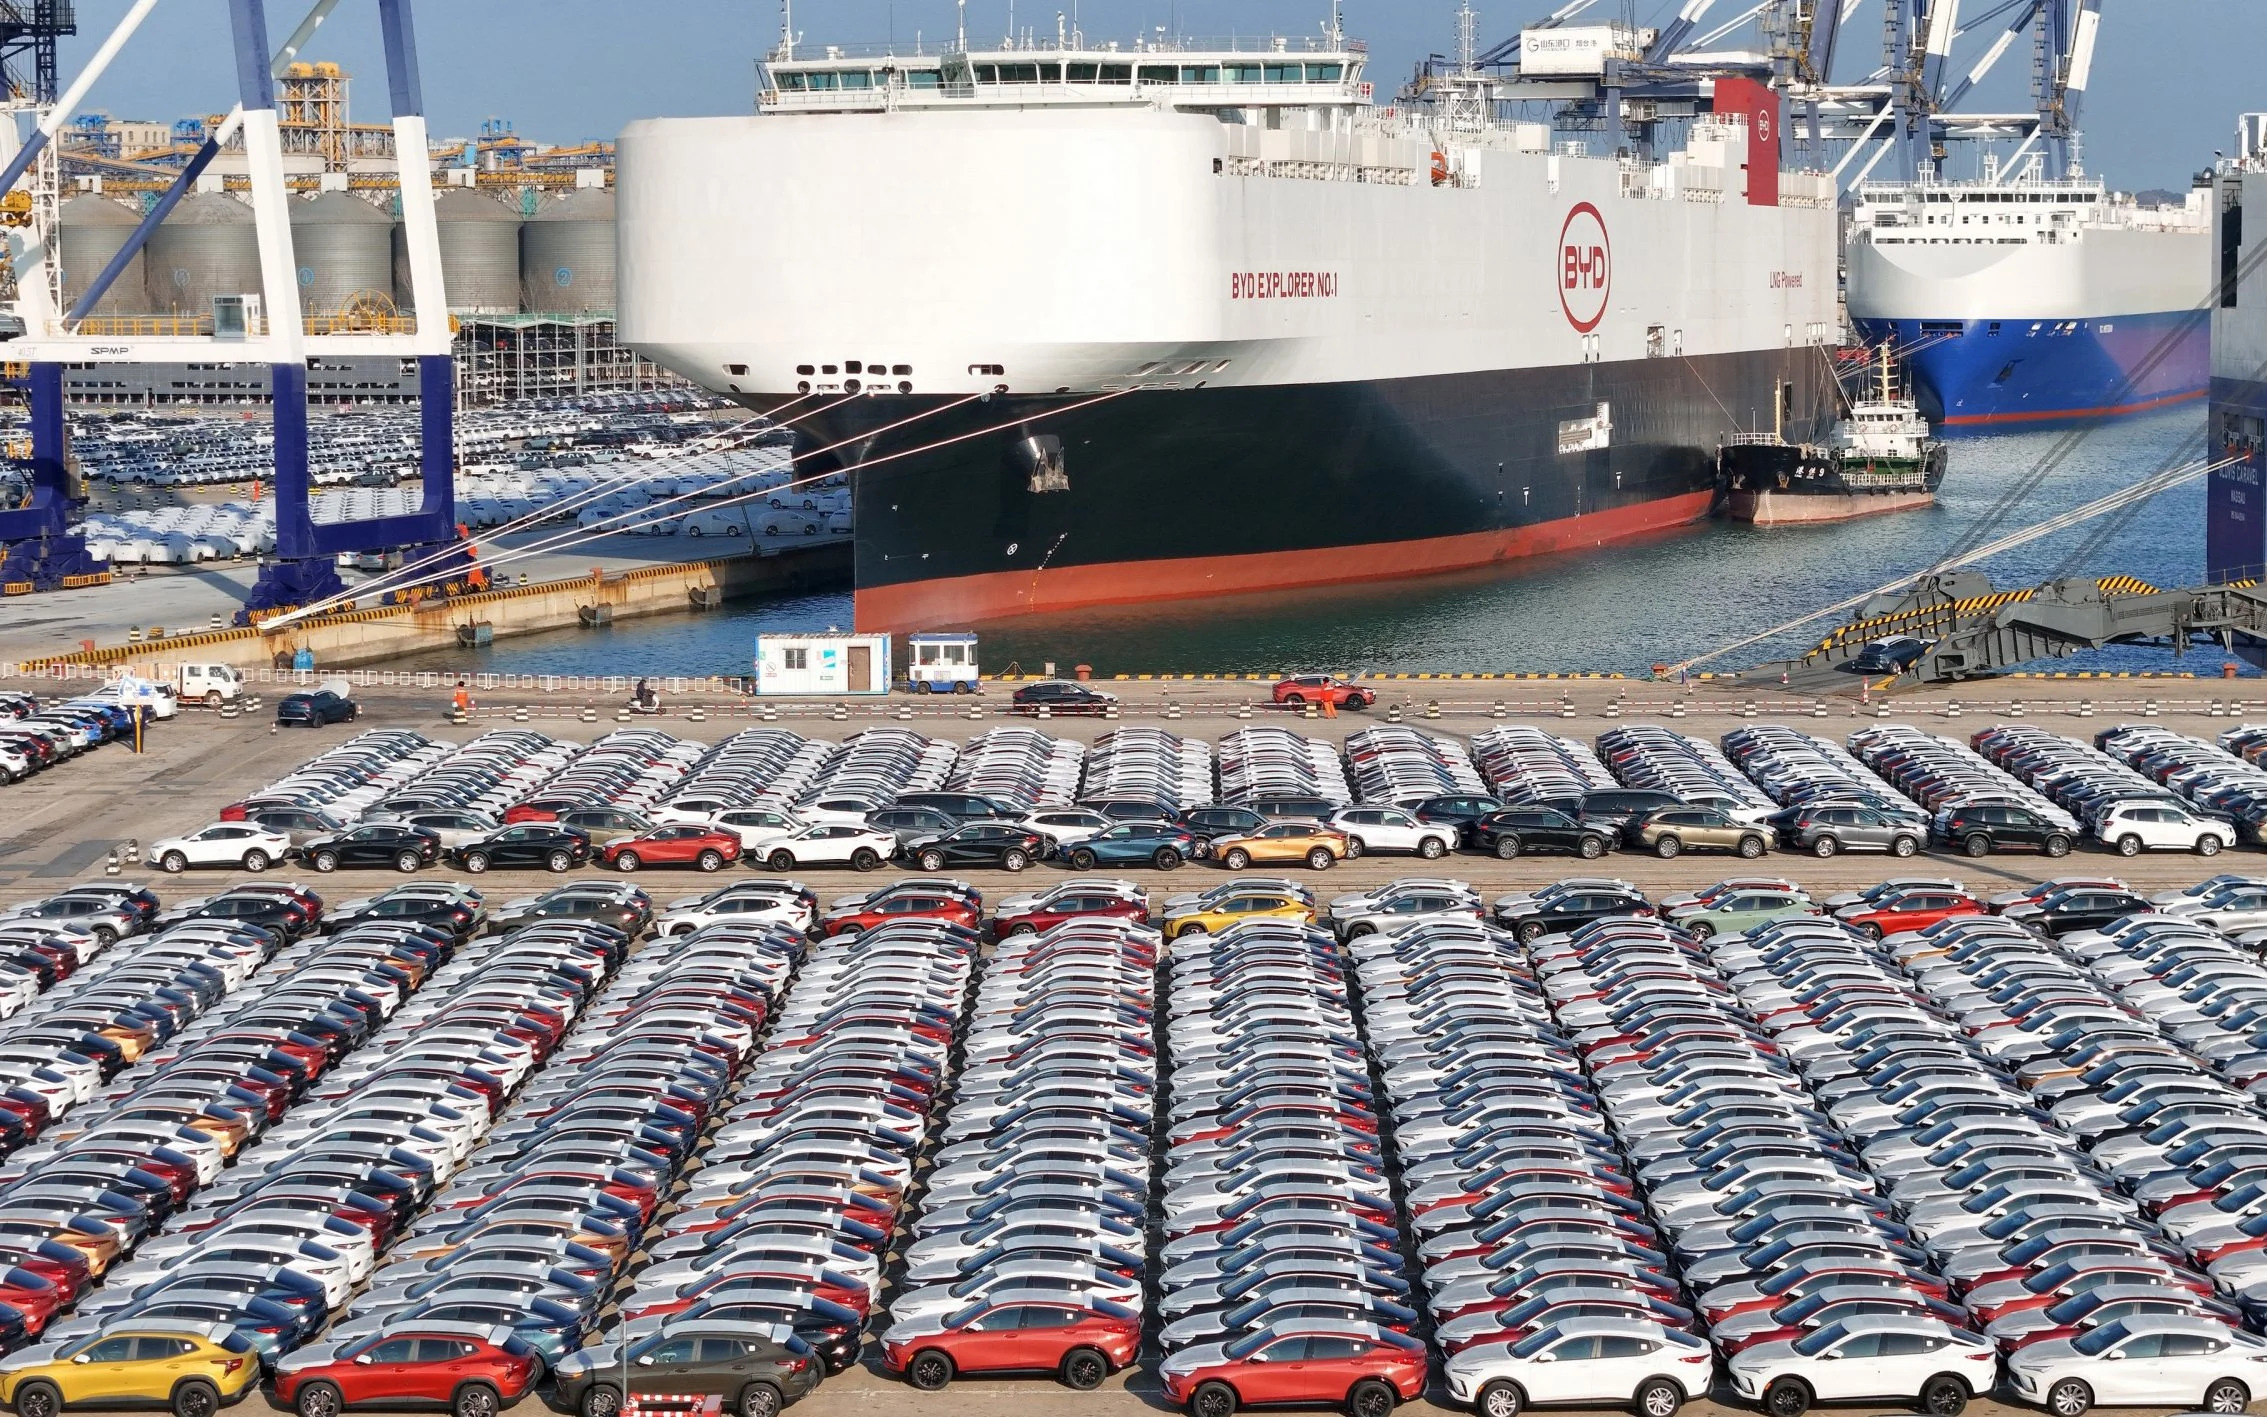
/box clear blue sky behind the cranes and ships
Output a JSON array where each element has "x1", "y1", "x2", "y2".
[{"x1": 44, "y1": 0, "x2": 2267, "y2": 190}]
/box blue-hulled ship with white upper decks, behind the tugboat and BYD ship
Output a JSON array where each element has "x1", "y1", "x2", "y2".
[{"x1": 1848, "y1": 175, "x2": 2210, "y2": 431}]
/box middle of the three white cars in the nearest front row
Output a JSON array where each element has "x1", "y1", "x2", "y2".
[{"x1": 1725, "y1": 1315, "x2": 1999, "y2": 1417}]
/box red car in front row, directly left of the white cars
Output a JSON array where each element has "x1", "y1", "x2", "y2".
[{"x1": 1156, "y1": 1320, "x2": 1426, "y2": 1417}]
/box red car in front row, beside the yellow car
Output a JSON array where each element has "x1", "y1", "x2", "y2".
[{"x1": 274, "y1": 1324, "x2": 544, "y2": 1417}]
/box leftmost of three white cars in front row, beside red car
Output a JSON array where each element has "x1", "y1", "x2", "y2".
[{"x1": 1444, "y1": 1320, "x2": 1716, "y2": 1417}]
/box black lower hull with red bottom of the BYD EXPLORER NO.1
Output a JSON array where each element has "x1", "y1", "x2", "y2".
[{"x1": 779, "y1": 349, "x2": 1839, "y2": 630}]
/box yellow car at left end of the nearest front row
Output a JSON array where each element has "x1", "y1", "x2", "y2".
[{"x1": 0, "y1": 1322, "x2": 261, "y2": 1417}]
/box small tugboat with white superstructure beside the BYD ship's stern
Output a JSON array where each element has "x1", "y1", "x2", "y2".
[{"x1": 1716, "y1": 345, "x2": 1945, "y2": 526}]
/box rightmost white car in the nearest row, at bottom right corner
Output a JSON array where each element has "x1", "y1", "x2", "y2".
[{"x1": 2006, "y1": 1315, "x2": 2267, "y2": 1417}]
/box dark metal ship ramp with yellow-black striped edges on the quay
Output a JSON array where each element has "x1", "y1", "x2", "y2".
[{"x1": 1737, "y1": 571, "x2": 2267, "y2": 691}]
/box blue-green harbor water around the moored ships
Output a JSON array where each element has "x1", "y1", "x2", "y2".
[{"x1": 410, "y1": 406, "x2": 2219, "y2": 676}]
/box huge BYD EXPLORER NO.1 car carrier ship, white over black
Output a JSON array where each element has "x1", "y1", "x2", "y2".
[{"x1": 617, "y1": 16, "x2": 1841, "y2": 630}]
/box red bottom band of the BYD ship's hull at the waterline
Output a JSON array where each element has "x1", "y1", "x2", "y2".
[{"x1": 857, "y1": 492, "x2": 1714, "y2": 635}]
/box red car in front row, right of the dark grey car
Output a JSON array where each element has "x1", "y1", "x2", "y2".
[{"x1": 882, "y1": 1290, "x2": 1140, "y2": 1392}]
